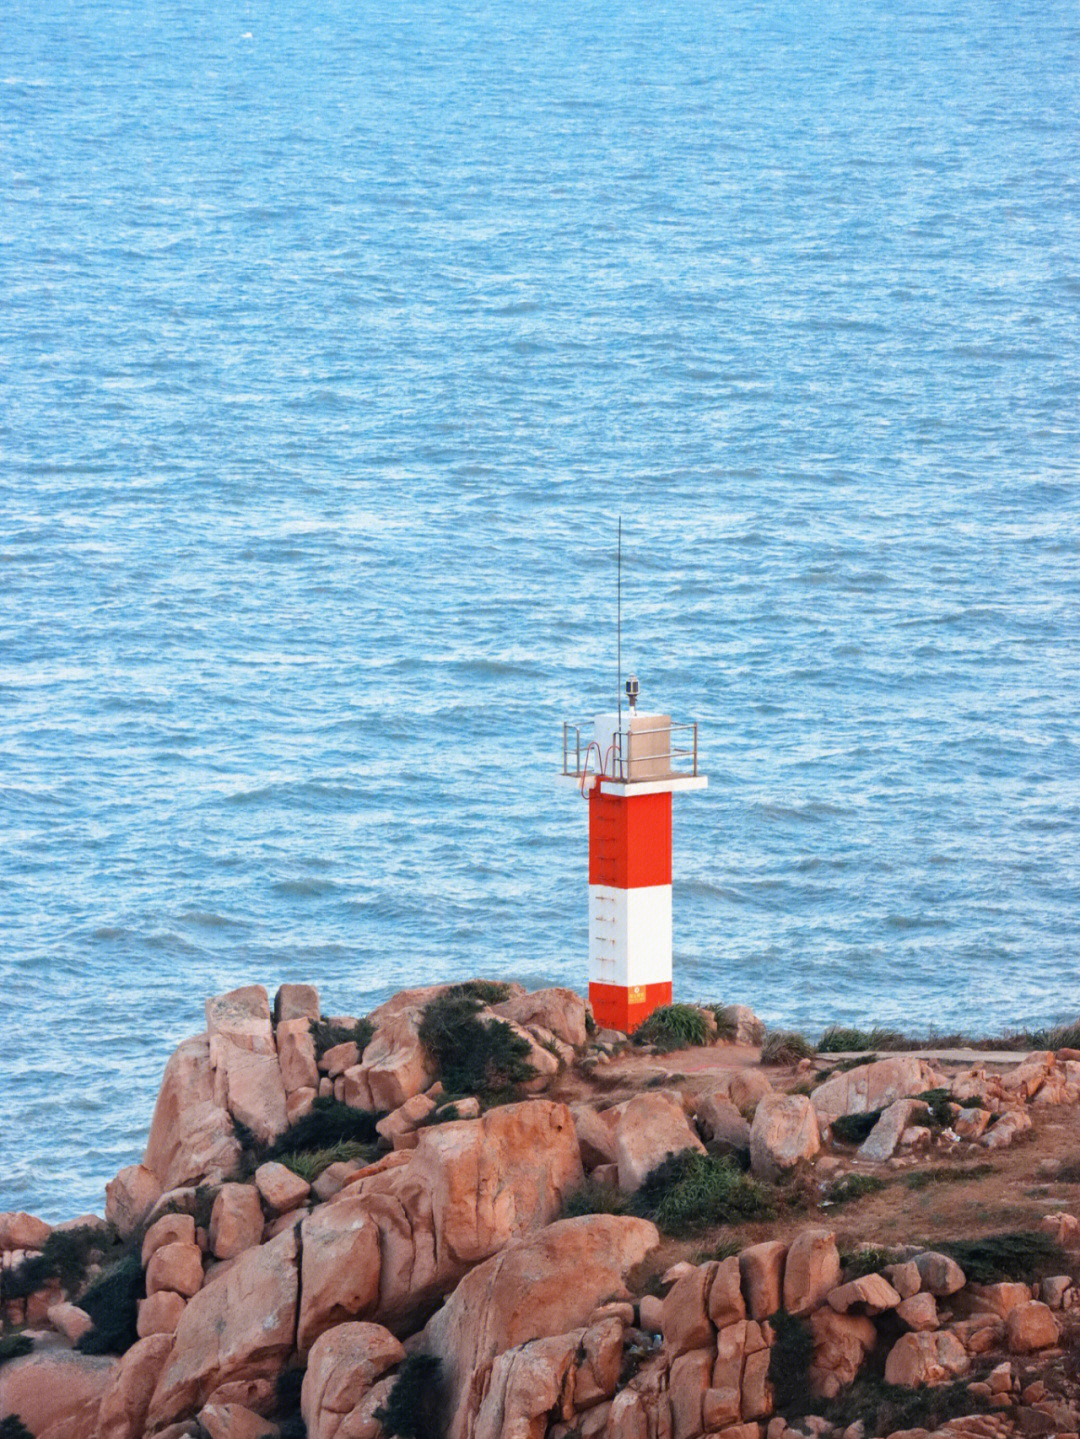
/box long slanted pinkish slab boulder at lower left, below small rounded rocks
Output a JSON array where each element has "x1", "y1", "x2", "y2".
[{"x1": 148, "y1": 1229, "x2": 299, "y2": 1429}]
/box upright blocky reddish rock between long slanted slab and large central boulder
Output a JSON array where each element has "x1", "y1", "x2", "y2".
[{"x1": 296, "y1": 1199, "x2": 381, "y2": 1354}]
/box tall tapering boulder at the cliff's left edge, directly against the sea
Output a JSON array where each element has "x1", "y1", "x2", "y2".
[{"x1": 142, "y1": 1035, "x2": 240, "y2": 1190}]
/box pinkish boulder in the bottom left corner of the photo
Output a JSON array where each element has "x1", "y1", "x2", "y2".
[{"x1": 0, "y1": 1348, "x2": 116, "y2": 1439}]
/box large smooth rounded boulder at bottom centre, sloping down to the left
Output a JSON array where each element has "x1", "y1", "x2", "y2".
[{"x1": 418, "y1": 1215, "x2": 659, "y2": 1439}]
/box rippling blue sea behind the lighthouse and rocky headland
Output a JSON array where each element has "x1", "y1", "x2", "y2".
[{"x1": 0, "y1": 0, "x2": 1080, "y2": 1217}]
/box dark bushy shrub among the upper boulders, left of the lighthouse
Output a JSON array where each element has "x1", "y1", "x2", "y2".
[{"x1": 420, "y1": 981, "x2": 536, "y2": 1101}]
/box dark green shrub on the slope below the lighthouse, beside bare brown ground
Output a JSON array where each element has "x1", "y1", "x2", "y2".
[{"x1": 637, "y1": 1150, "x2": 774, "y2": 1238}]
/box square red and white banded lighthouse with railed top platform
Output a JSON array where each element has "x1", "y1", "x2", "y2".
[{"x1": 562, "y1": 675, "x2": 708, "y2": 1033}]
